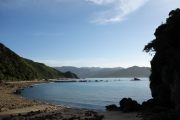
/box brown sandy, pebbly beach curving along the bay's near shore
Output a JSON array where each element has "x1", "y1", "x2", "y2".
[{"x1": 0, "y1": 81, "x2": 141, "y2": 120}]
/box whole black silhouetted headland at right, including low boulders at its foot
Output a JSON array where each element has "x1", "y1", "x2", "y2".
[{"x1": 106, "y1": 8, "x2": 180, "y2": 120}]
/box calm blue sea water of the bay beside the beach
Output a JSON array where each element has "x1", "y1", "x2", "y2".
[{"x1": 22, "y1": 78, "x2": 151, "y2": 110}]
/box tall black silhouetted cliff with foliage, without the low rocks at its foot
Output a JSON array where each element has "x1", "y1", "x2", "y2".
[{"x1": 144, "y1": 9, "x2": 180, "y2": 110}]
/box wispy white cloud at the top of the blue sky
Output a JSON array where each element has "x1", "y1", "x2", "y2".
[{"x1": 86, "y1": 0, "x2": 148, "y2": 24}]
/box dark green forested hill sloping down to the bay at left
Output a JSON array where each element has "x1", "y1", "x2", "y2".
[{"x1": 0, "y1": 43, "x2": 78, "y2": 80}]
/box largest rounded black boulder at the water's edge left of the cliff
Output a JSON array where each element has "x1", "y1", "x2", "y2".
[{"x1": 120, "y1": 98, "x2": 141, "y2": 112}]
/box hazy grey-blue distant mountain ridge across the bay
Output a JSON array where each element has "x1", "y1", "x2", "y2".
[{"x1": 55, "y1": 66, "x2": 151, "y2": 78}]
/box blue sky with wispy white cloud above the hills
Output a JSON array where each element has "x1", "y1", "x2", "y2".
[{"x1": 0, "y1": 0, "x2": 180, "y2": 67}]
